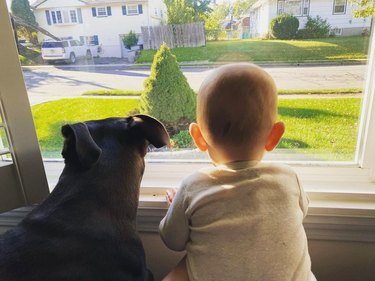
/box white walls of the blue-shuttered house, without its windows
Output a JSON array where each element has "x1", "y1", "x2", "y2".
[{"x1": 35, "y1": 0, "x2": 166, "y2": 57}]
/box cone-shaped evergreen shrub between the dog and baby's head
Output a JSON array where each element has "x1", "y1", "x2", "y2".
[{"x1": 140, "y1": 43, "x2": 196, "y2": 135}]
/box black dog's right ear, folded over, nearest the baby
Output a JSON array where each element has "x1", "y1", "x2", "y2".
[{"x1": 130, "y1": 114, "x2": 169, "y2": 148}]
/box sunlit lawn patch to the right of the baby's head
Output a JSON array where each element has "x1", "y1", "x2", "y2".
[{"x1": 278, "y1": 98, "x2": 361, "y2": 160}]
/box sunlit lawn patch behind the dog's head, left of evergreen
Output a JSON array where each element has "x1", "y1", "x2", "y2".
[{"x1": 32, "y1": 98, "x2": 139, "y2": 157}]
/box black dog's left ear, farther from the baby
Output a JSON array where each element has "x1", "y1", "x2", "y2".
[{"x1": 61, "y1": 123, "x2": 102, "y2": 168}]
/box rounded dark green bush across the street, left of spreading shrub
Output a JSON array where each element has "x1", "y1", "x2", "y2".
[{"x1": 270, "y1": 14, "x2": 299, "y2": 39}]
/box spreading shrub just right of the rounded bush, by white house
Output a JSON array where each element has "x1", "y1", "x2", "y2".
[{"x1": 298, "y1": 16, "x2": 331, "y2": 39}]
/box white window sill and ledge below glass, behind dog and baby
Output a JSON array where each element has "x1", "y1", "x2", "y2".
[{"x1": 13, "y1": 161, "x2": 375, "y2": 242}]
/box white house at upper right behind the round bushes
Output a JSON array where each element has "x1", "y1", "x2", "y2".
[{"x1": 250, "y1": 0, "x2": 371, "y2": 37}]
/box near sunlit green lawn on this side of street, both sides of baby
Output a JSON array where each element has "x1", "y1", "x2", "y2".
[{"x1": 32, "y1": 98, "x2": 361, "y2": 160}]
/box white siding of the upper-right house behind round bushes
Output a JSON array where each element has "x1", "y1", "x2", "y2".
[{"x1": 250, "y1": 0, "x2": 371, "y2": 37}]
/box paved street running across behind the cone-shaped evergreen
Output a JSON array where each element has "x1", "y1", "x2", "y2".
[{"x1": 24, "y1": 65, "x2": 366, "y2": 105}]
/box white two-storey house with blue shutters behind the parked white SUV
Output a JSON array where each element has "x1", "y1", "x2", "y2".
[{"x1": 32, "y1": 0, "x2": 167, "y2": 57}]
